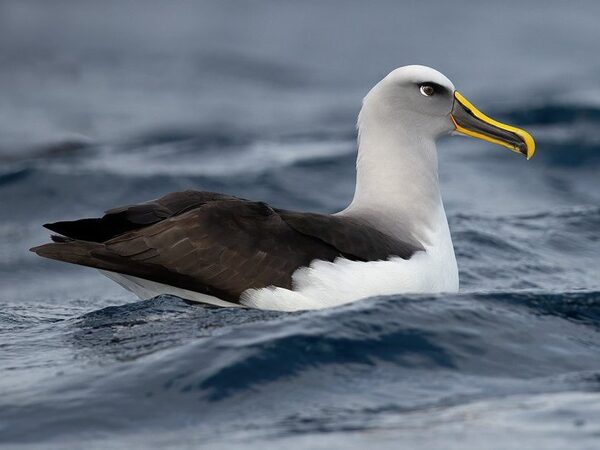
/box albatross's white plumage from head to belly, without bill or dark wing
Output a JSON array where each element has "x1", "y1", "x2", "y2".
[{"x1": 106, "y1": 66, "x2": 458, "y2": 311}]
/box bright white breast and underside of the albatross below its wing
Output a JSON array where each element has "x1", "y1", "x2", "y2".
[{"x1": 101, "y1": 206, "x2": 458, "y2": 311}]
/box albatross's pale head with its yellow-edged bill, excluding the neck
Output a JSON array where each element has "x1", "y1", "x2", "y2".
[{"x1": 361, "y1": 65, "x2": 535, "y2": 159}]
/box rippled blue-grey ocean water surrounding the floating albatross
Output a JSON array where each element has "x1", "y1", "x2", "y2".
[{"x1": 0, "y1": 0, "x2": 600, "y2": 449}]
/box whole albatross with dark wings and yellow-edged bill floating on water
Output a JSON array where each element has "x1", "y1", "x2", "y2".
[{"x1": 31, "y1": 65, "x2": 535, "y2": 311}]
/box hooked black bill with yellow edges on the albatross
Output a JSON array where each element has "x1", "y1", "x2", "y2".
[{"x1": 450, "y1": 91, "x2": 535, "y2": 159}]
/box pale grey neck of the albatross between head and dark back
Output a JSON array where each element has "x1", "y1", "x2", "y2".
[{"x1": 339, "y1": 108, "x2": 447, "y2": 244}]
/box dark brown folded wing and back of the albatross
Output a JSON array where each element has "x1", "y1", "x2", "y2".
[{"x1": 32, "y1": 191, "x2": 420, "y2": 302}]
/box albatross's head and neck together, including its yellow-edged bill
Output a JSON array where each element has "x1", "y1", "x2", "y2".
[{"x1": 343, "y1": 66, "x2": 535, "y2": 241}]
